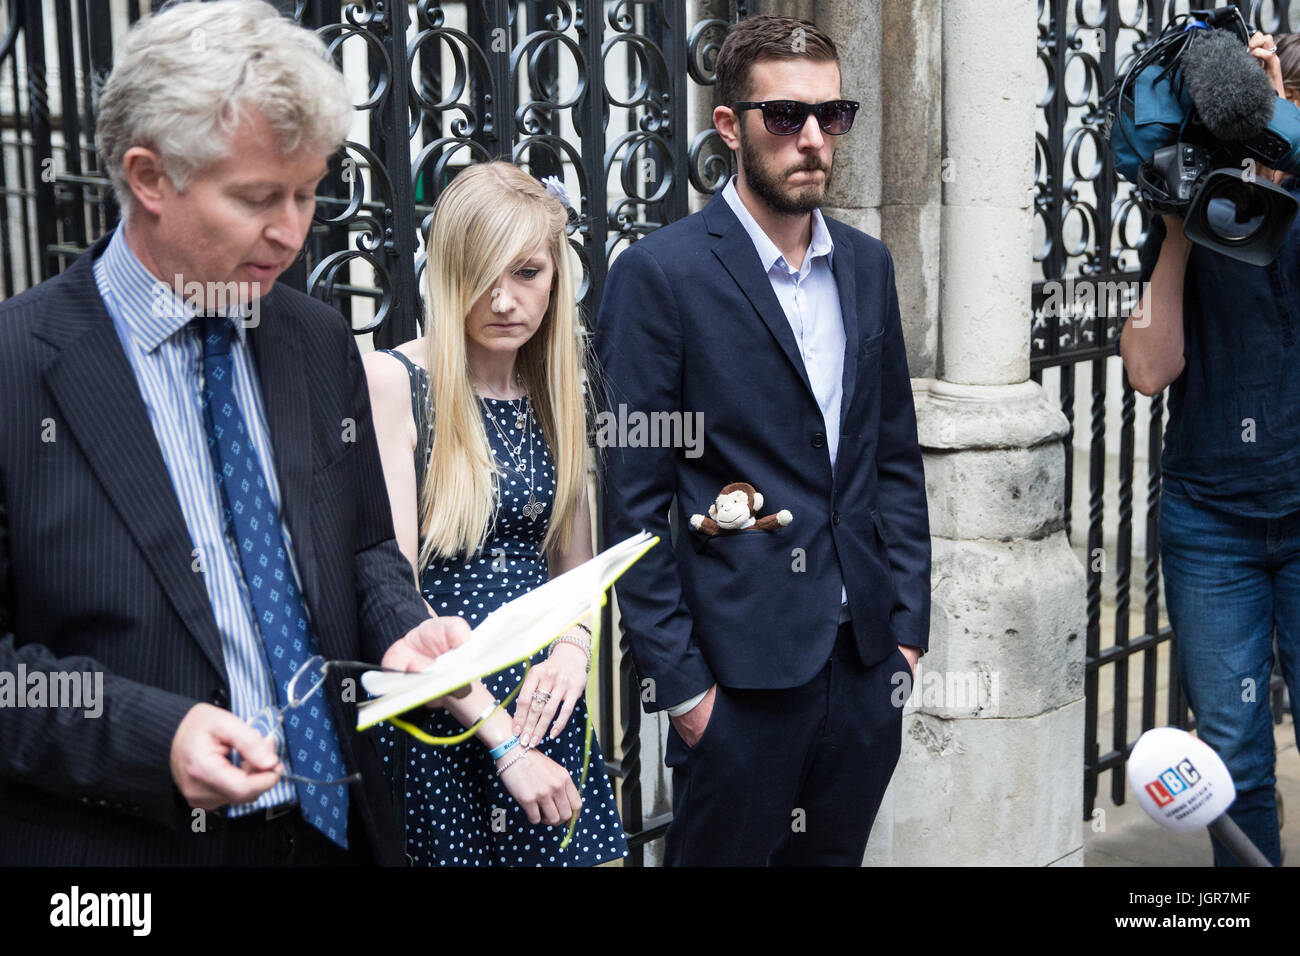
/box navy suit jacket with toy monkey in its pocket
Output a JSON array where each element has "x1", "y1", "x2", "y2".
[{"x1": 595, "y1": 194, "x2": 930, "y2": 710}]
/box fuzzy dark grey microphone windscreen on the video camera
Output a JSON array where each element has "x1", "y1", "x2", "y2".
[{"x1": 1182, "y1": 30, "x2": 1278, "y2": 143}]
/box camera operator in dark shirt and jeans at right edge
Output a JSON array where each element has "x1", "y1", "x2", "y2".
[{"x1": 1119, "y1": 34, "x2": 1300, "y2": 866}]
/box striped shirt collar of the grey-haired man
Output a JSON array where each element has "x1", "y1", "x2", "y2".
[{"x1": 99, "y1": 226, "x2": 247, "y2": 352}]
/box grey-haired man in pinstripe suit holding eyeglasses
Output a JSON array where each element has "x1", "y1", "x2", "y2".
[{"x1": 0, "y1": 0, "x2": 465, "y2": 865}]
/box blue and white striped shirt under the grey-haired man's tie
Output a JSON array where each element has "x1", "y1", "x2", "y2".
[{"x1": 95, "y1": 229, "x2": 302, "y2": 816}]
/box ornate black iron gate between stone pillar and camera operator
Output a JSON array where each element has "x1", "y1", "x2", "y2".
[{"x1": 1031, "y1": 0, "x2": 1291, "y2": 817}]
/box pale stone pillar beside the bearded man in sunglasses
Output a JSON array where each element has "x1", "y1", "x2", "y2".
[{"x1": 867, "y1": 0, "x2": 1084, "y2": 865}]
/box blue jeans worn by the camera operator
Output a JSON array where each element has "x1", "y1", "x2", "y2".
[{"x1": 1160, "y1": 483, "x2": 1300, "y2": 866}]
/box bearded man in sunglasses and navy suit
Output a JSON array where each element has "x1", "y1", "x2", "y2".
[{"x1": 595, "y1": 17, "x2": 930, "y2": 865}]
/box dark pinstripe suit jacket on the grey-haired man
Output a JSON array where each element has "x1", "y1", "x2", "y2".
[{"x1": 0, "y1": 237, "x2": 428, "y2": 865}]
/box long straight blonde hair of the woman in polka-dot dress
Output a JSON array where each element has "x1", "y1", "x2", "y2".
[{"x1": 420, "y1": 161, "x2": 586, "y2": 567}]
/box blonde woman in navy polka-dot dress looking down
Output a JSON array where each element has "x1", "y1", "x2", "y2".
[{"x1": 365, "y1": 161, "x2": 627, "y2": 866}]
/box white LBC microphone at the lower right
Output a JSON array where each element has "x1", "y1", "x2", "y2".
[{"x1": 1127, "y1": 727, "x2": 1273, "y2": 866}]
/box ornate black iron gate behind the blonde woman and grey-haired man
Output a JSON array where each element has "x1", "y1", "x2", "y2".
[{"x1": 0, "y1": 0, "x2": 746, "y2": 865}]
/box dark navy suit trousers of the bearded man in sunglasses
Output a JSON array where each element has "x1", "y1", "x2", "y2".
[{"x1": 664, "y1": 624, "x2": 909, "y2": 866}]
